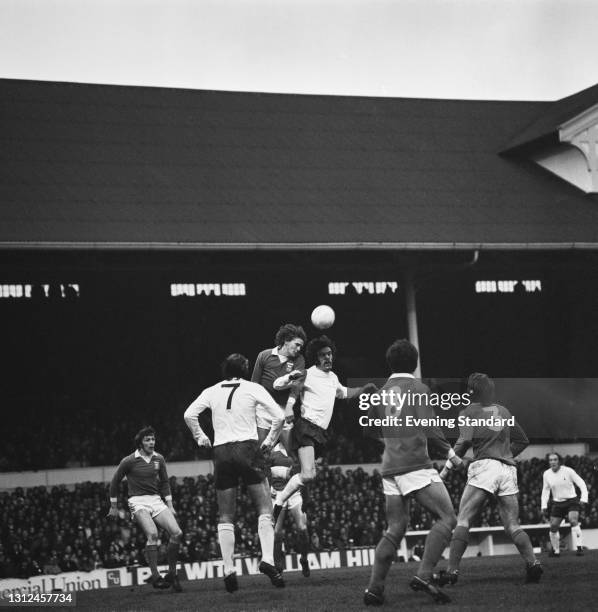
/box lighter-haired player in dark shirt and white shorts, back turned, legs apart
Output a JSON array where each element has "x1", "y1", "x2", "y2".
[{"x1": 434, "y1": 372, "x2": 542, "y2": 585}]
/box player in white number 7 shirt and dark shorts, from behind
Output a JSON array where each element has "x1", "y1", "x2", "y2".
[{"x1": 185, "y1": 353, "x2": 284, "y2": 593}]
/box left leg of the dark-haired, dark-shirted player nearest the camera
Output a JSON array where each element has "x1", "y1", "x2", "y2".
[{"x1": 364, "y1": 495, "x2": 409, "y2": 605}]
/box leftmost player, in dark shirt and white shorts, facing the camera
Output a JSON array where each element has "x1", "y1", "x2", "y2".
[{"x1": 108, "y1": 427, "x2": 183, "y2": 591}]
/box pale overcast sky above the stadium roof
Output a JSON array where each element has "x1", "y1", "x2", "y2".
[{"x1": 0, "y1": 0, "x2": 598, "y2": 100}]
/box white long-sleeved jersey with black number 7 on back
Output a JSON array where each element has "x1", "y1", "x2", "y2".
[{"x1": 185, "y1": 378, "x2": 284, "y2": 446}]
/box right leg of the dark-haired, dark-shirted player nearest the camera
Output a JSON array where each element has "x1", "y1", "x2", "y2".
[{"x1": 415, "y1": 482, "x2": 457, "y2": 580}]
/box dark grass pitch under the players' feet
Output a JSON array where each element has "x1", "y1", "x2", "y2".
[{"x1": 77, "y1": 551, "x2": 598, "y2": 612}]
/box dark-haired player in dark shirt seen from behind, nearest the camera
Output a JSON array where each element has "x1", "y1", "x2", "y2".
[{"x1": 364, "y1": 340, "x2": 461, "y2": 605}]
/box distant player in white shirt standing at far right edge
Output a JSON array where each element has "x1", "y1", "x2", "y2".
[{"x1": 541, "y1": 453, "x2": 588, "y2": 557}]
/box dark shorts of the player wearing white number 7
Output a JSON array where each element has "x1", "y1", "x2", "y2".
[{"x1": 214, "y1": 440, "x2": 266, "y2": 491}]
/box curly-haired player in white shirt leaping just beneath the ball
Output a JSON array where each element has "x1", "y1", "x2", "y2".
[{"x1": 274, "y1": 336, "x2": 378, "y2": 520}]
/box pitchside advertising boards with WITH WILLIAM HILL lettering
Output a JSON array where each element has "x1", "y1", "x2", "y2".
[{"x1": 0, "y1": 524, "x2": 598, "y2": 600}]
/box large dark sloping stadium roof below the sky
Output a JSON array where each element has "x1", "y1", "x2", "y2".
[{"x1": 0, "y1": 80, "x2": 598, "y2": 249}]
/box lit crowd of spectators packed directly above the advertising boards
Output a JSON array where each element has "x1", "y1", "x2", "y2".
[{"x1": 0, "y1": 457, "x2": 598, "y2": 578}]
